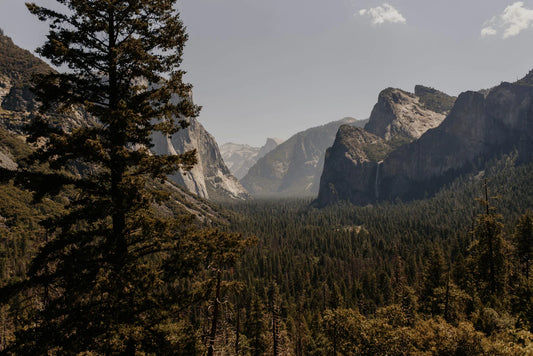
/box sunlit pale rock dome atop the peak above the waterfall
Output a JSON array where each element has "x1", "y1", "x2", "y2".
[{"x1": 365, "y1": 86, "x2": 452, "y2": 146}]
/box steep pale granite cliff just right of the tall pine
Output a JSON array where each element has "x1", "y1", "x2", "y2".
[{"x1": 153, "y1": 118, "x2": 249, "y2": 201}]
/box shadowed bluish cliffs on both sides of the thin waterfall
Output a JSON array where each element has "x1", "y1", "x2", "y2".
[{"x1": 317, "y1": 81, "x2": 533, "y2": 205}]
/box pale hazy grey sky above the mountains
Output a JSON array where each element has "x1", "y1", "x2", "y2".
[{"x1": 0, "y1": 0, "x2": 533, "y2": 146}]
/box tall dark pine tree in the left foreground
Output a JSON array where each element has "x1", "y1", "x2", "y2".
[{"x1": 2, "y1": 0, "x2": 248, "y2": 355}]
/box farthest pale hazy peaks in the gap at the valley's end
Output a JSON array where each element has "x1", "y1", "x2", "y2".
[{"x1": 220, "y1": 138, "x2": 283, "y2": 179}]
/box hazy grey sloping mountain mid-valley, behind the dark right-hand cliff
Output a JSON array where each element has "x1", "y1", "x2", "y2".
[{"x1": 241, "y1": 118, "x2": 366, "y2": 197}]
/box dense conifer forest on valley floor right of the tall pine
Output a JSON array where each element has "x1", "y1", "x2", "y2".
[{"x1": 209, "y1": 156, "x2": 533, "y2": 355}]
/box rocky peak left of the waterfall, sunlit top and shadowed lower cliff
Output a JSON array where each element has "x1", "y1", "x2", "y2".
[{"x1": 316, "y1": 86, "x2": 455, "y2": 206}]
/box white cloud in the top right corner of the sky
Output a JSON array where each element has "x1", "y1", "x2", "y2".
[{"x1": 481, "y1": 1, "x2": 533, "y2": 38}]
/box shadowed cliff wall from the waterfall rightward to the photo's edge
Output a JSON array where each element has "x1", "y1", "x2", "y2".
[{"x1": 380, "y1": 83, "x2": 533, "y2": 199}]
